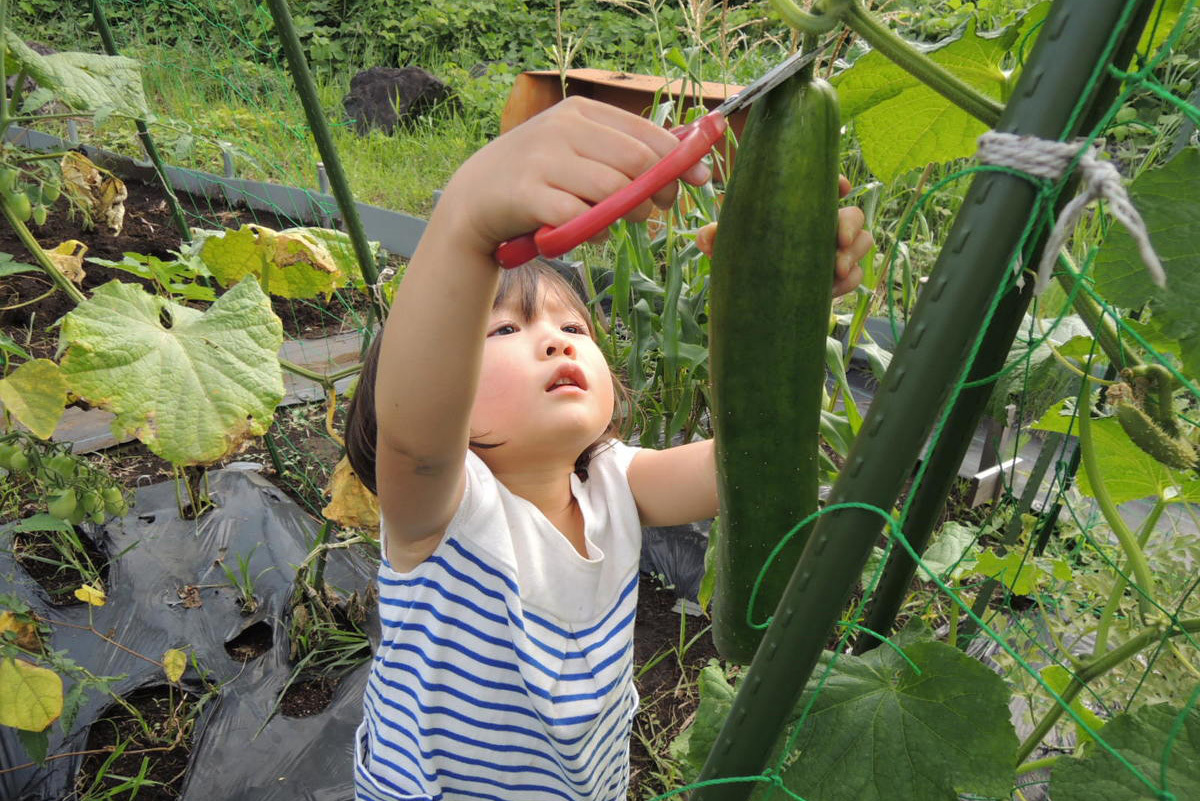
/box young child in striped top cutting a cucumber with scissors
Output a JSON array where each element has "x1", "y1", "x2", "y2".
[{"x1": 347, "y1": 98, "x2": 871, "y2": 801}]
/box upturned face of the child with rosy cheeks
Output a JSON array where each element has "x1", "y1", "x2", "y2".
[{"x1": 470, "y1": 288, "x2": 613, "y2": 466}]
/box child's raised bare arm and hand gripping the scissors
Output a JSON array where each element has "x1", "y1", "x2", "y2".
[{"x1": 374, "y1": 98, "x2": 707, "y2": 566}]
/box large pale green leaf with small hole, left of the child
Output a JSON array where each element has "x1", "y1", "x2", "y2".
[{"x1": 61, "y1": 278, "x2": 283, "y2": 465}]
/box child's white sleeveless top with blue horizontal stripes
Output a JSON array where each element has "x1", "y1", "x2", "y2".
[{"x1": 355, "y1": 442, "x2": 641, "y2": 801}]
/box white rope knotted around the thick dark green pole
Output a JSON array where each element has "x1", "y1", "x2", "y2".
[{"x1": 976, "y1": 131, "x2": 1166, "y2": 295}]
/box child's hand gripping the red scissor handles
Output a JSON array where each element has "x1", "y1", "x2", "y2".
[{"x1": 431, "y1": 97, "x2": 709, "y2": 260}]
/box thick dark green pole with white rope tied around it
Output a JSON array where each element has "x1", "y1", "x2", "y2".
[{"x1": 692, "y1": 0, "x2": 1152, "y2": 801}]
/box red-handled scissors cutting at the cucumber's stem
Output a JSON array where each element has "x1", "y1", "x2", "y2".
[{"x1": 494, "y1": 42, "x2": 828, "y2": 267}]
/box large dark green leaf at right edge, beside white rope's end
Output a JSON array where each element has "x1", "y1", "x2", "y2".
[{"x1": 1096, "y1": 147, "x2": 1200, "y2": 375}]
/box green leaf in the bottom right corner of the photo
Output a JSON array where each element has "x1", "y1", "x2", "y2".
[{"x1": 1050, "y1": 704, "x2": 1200, "y2": 801}]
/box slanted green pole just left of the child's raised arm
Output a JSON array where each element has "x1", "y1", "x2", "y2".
[{"x1": 266, "y1": 0, "x2": 386, "y2": 326}]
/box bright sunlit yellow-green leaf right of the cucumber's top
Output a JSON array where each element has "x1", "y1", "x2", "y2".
[{"x1": 834, "y1": 23, "x2": 1020, "y2": 181}]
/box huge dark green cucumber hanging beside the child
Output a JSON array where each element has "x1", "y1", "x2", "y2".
[{"x1": 709, "y1": 68, "x2": 841, "y2": 663}]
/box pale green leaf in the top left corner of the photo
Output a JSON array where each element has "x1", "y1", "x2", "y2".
[{"x1": 5, "y1": 30, "x2": 150, "y2": 119}]
